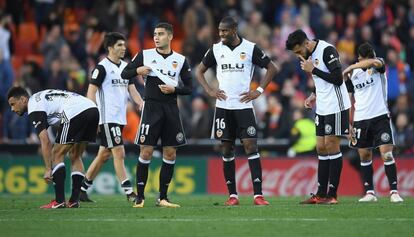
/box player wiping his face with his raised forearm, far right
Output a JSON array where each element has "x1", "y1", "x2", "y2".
[{"x1": 343, "y1": 43, "x2": 403, "y2": 202}]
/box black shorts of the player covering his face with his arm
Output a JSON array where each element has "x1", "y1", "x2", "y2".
[{"x1": 350, "y1": 114, "x2": 394, "y2": 148}]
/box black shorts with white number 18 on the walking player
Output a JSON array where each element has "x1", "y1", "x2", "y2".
[{"x1": 98, "y1": 123, "x2": 124, "y2": 148}]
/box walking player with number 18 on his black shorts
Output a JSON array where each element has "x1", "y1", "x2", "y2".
[{"x1": 81, "y1": 32, "x2": 143, "y2": 202}]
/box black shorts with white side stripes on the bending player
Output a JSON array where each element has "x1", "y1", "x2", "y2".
[{"x1": 55, "y1": 108, "x2": 99, "y2": 144}]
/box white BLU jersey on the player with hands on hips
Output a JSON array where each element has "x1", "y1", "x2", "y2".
[{"x1": 213, "y1": 39, "x2": 255, "y2": 109}]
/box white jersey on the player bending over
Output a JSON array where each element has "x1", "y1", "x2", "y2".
[{"x1": 28, "y1": 89, "x2": 96, "y2": 125}]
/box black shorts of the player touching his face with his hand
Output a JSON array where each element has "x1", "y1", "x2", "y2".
[{"x1": 315, "y1": 109, "x2": 349, "y2": 137}]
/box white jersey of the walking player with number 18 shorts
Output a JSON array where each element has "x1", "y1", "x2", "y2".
[{"x1": 91, "y1": 58, "x2": 130, "y2": 125}]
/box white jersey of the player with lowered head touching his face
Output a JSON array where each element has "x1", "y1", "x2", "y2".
[{"x1": 312, "y1": 40, "x2": 351, "y2": 115}]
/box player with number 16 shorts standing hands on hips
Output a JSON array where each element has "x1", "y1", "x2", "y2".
[{"x1": 196, "y1": 17, "x2": 277, "y2": 206}]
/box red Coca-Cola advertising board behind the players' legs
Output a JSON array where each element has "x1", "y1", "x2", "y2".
[{"x1": 207, "y1": 158, "x2": 414, "y2": 196}]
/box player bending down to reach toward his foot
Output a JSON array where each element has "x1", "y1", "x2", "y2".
[{"x1": 7, "y1": 87, "x2": 99, "y2": 209}]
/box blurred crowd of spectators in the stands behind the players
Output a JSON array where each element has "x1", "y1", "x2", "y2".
[{"x1": 0, "y1": 0, "x2": 414, "y2": 154}]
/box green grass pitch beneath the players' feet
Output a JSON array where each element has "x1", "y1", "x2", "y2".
[{"x1": 0, "y1": 195, "x2": 414, "y2": 237}]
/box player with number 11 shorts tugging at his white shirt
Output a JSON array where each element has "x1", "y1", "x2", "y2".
[{"x1": 121, "y1": 23, "x2": 192, "y2": 208}]
